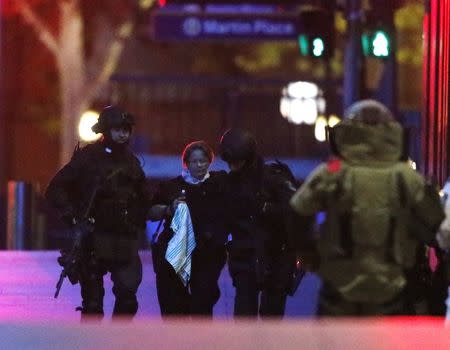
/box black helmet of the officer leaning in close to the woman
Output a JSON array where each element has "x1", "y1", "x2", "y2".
[{"x1": 219, "y1": 129, "x2": 256, "y2": 162}]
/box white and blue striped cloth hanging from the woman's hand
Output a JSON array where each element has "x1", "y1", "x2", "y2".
[{"x1": 166, "y1": 203, "x2": 196, "y2": 286}]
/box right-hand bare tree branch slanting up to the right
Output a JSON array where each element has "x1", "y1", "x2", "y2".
[{"x1": 86, "y1": 20, "x2": 134, "y2": 101}]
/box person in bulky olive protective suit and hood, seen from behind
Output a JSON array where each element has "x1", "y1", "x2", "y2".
[{"x1": 291, "y1": 100, "x2": 443, "y2": 316}]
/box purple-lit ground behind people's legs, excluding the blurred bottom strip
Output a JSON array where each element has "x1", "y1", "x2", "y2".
[{"x1": 0, "y1": 251, "x2": 320, "y2": 320}]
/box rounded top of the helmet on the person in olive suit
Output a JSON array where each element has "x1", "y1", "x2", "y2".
[{"x1": 344, "y1": 100, "x2": 394, "y2": 124}]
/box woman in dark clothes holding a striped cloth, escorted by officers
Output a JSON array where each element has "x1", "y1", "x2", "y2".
[{"x1": 150, "y1": 141, "x2": 228, "y2": 317}]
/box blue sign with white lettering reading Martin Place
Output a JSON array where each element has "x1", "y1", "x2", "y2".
[{"x1": 151, "y1": 13, "x2": 299, "y2": 41}]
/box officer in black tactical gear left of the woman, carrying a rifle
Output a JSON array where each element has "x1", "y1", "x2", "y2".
[{"x1": 46, "y1": 106, "x2": 150, "y2": 317}]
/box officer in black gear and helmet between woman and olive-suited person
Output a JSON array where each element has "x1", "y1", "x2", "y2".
[{"x1": 219, "y1": 129, "x2": 296, "y2": 317}]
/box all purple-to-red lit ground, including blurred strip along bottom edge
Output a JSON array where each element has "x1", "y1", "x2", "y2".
[{"x1": 0, "y1": 251, "x2": 450, "y2": 350}]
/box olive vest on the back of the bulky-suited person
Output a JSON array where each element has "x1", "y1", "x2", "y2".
[{"x1": 319, "y1": 162, "x2": 419, "y2": 303}]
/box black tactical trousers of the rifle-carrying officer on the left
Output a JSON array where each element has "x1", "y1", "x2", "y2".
[{"x1": 80, "y1": 255, "x2": 142, "y2": 316}]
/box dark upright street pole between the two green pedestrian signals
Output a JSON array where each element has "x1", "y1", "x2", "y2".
[{"x1": 343, "y1": 0, "x2": 364, "y2": 109}]
